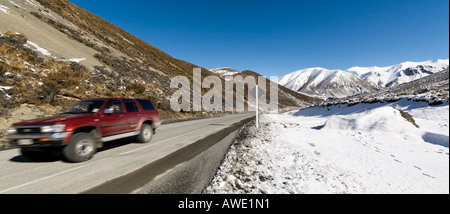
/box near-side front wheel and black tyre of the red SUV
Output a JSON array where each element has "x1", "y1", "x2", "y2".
[{"x1": 63, "y1": 132, "x2": 97, "y2": 162}]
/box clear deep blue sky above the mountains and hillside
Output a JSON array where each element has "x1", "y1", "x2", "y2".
[{"x1": 70, "y1": 0, "x2": 449, "y2": 77}]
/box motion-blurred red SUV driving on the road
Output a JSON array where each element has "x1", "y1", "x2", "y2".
[{"x1": 7, "y1": 98, "x2": 161, "y2": 162}]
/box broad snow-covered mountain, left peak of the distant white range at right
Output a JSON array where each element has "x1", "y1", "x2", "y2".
[{"x1": 278, "y1": 67, "x2": 377, "y2": 98}]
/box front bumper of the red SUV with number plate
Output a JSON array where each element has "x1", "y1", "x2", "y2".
[{"x1": 6, "y1": 132, "x2": 70, "y2": 147}]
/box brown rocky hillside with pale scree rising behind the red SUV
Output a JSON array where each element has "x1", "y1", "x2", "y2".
[{"x1": 0, "y1": 0, "x2": 316, "y2": 149}]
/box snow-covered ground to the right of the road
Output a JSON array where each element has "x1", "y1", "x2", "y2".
[{"x1": 204, "y1": 99, "x2": 449, "y2": 194}]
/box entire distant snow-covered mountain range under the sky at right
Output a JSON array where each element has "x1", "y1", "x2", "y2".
[{"x1": 278, "y1": 59, "x2": 449, "y2": 98}]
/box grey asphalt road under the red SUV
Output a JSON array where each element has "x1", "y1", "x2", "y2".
[{"x1": 0, "y1": 114, "x2": 254, "y2": 194}]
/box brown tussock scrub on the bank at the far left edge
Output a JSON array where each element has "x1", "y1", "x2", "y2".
[{"x1": 0, "y1": 31, "x2": 90, "y2": 109}]
